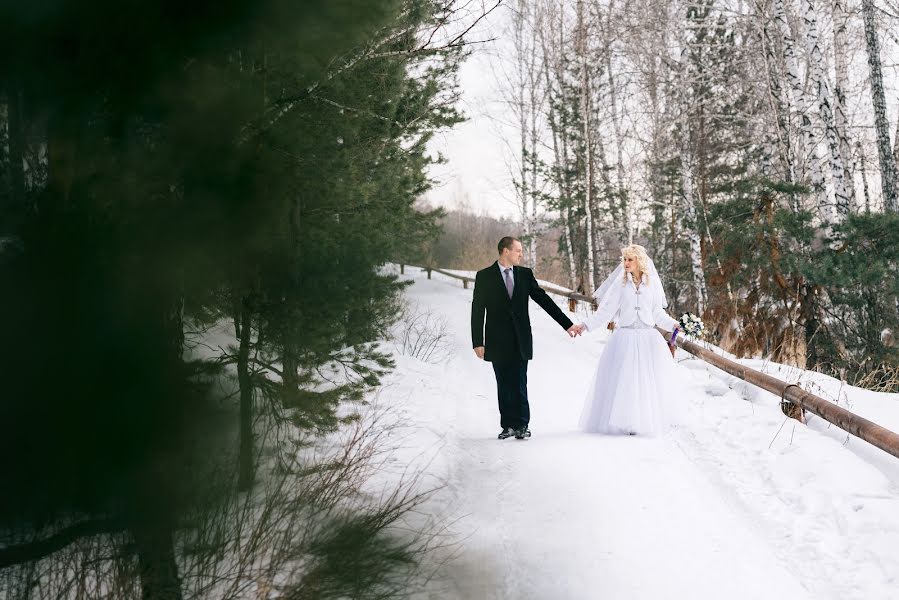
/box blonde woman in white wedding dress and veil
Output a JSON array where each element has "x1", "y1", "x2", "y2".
[{"x1": 578, "y1": 244, "x2": 680, "y2": 436}]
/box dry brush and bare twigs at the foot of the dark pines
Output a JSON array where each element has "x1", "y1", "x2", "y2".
[{"x1": 0, "y1": 400, "x2": 447, "y2": 600}]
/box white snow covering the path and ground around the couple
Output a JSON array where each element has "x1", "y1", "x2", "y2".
[{"x1": 379, "y1": 266, "x2": 899, "y2": 600}]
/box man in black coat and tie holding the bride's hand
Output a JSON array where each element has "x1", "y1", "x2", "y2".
[{"x1": 471, "y1": 237, "x2": 580, "y2": 440}]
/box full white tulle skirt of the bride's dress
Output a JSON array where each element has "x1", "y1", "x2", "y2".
[{"x1": 579, "y1": 328, "x2": 680, "y2": 436}]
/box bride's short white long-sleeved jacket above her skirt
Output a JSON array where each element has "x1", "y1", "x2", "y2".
[{"x1": 584, "y1": 273, "x2": 679, "y2": 331}]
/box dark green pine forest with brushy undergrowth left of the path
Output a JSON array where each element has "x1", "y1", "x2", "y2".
[{"x1": 0, "y1": 0, "x2": 484, "y2": 599}]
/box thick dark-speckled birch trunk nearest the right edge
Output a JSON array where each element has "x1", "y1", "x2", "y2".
[{"x1": 862, "y1": 0, "x2": 899, "y2": 212}]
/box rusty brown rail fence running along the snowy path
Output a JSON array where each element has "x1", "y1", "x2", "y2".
[{"x1": 400, "y1": 264, "x2": 899, "y2": 458}]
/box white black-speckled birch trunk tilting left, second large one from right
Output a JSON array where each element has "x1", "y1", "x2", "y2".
[{"x1": 804, "y1": 0, "x2": 850, "y2": 219}]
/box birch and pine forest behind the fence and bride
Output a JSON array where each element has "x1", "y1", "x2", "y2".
[{"x1": 497, "y1": 0, "x2": 899, "y2": 384}]
